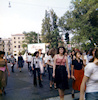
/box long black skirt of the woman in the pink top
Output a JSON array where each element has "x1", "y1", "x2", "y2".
[{"x1": 55, "y1": 65, "x2": 69, "y2": 90}]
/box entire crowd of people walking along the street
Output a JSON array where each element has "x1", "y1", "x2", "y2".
[{"x1": 0, "y1": 47, "x2": 98, "y2": 100}]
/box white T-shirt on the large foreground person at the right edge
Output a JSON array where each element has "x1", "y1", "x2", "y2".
[{"x1": 84, "y1": 63, "x2": 98, "y2": 93}]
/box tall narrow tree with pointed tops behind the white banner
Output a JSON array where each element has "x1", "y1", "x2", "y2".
[{"x1": 42, "y1": 10, "x2": 60, "y2": 48}]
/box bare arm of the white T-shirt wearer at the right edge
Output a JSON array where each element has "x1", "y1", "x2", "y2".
[{"x1": 80, "y1": 75, "x2": 89, "y2": 100}]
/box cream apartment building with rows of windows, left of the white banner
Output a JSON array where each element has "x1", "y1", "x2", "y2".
[{"x1": 12, "y1": 34, "x2": 25, "y2": 56}]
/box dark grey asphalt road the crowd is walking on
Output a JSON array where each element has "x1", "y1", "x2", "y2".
[{"x1": 0, "y1": 63, "x2": 78, "y2": 100}]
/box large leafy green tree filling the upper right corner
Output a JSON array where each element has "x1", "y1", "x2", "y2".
[{"x1": 59, "y1": 0, "x2": 98, "y2": 47}]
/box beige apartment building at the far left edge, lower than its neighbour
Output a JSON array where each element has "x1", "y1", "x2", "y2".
[{"x1": 0, "y1": 38, "x2": 12, "y2": 55}]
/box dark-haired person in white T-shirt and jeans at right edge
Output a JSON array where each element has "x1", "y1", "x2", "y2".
[{"x1": 80, "y1": 49, "x2": 98, "y2": 100}]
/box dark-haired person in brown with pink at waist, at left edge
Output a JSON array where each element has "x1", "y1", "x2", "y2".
[{"x1": 0, "y1": 51, "x2": 10, "y2": 95}]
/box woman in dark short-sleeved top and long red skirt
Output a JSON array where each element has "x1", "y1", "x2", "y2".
[{"x1": 71, "y1": 52, "x2": 84, "y2": 98}]
